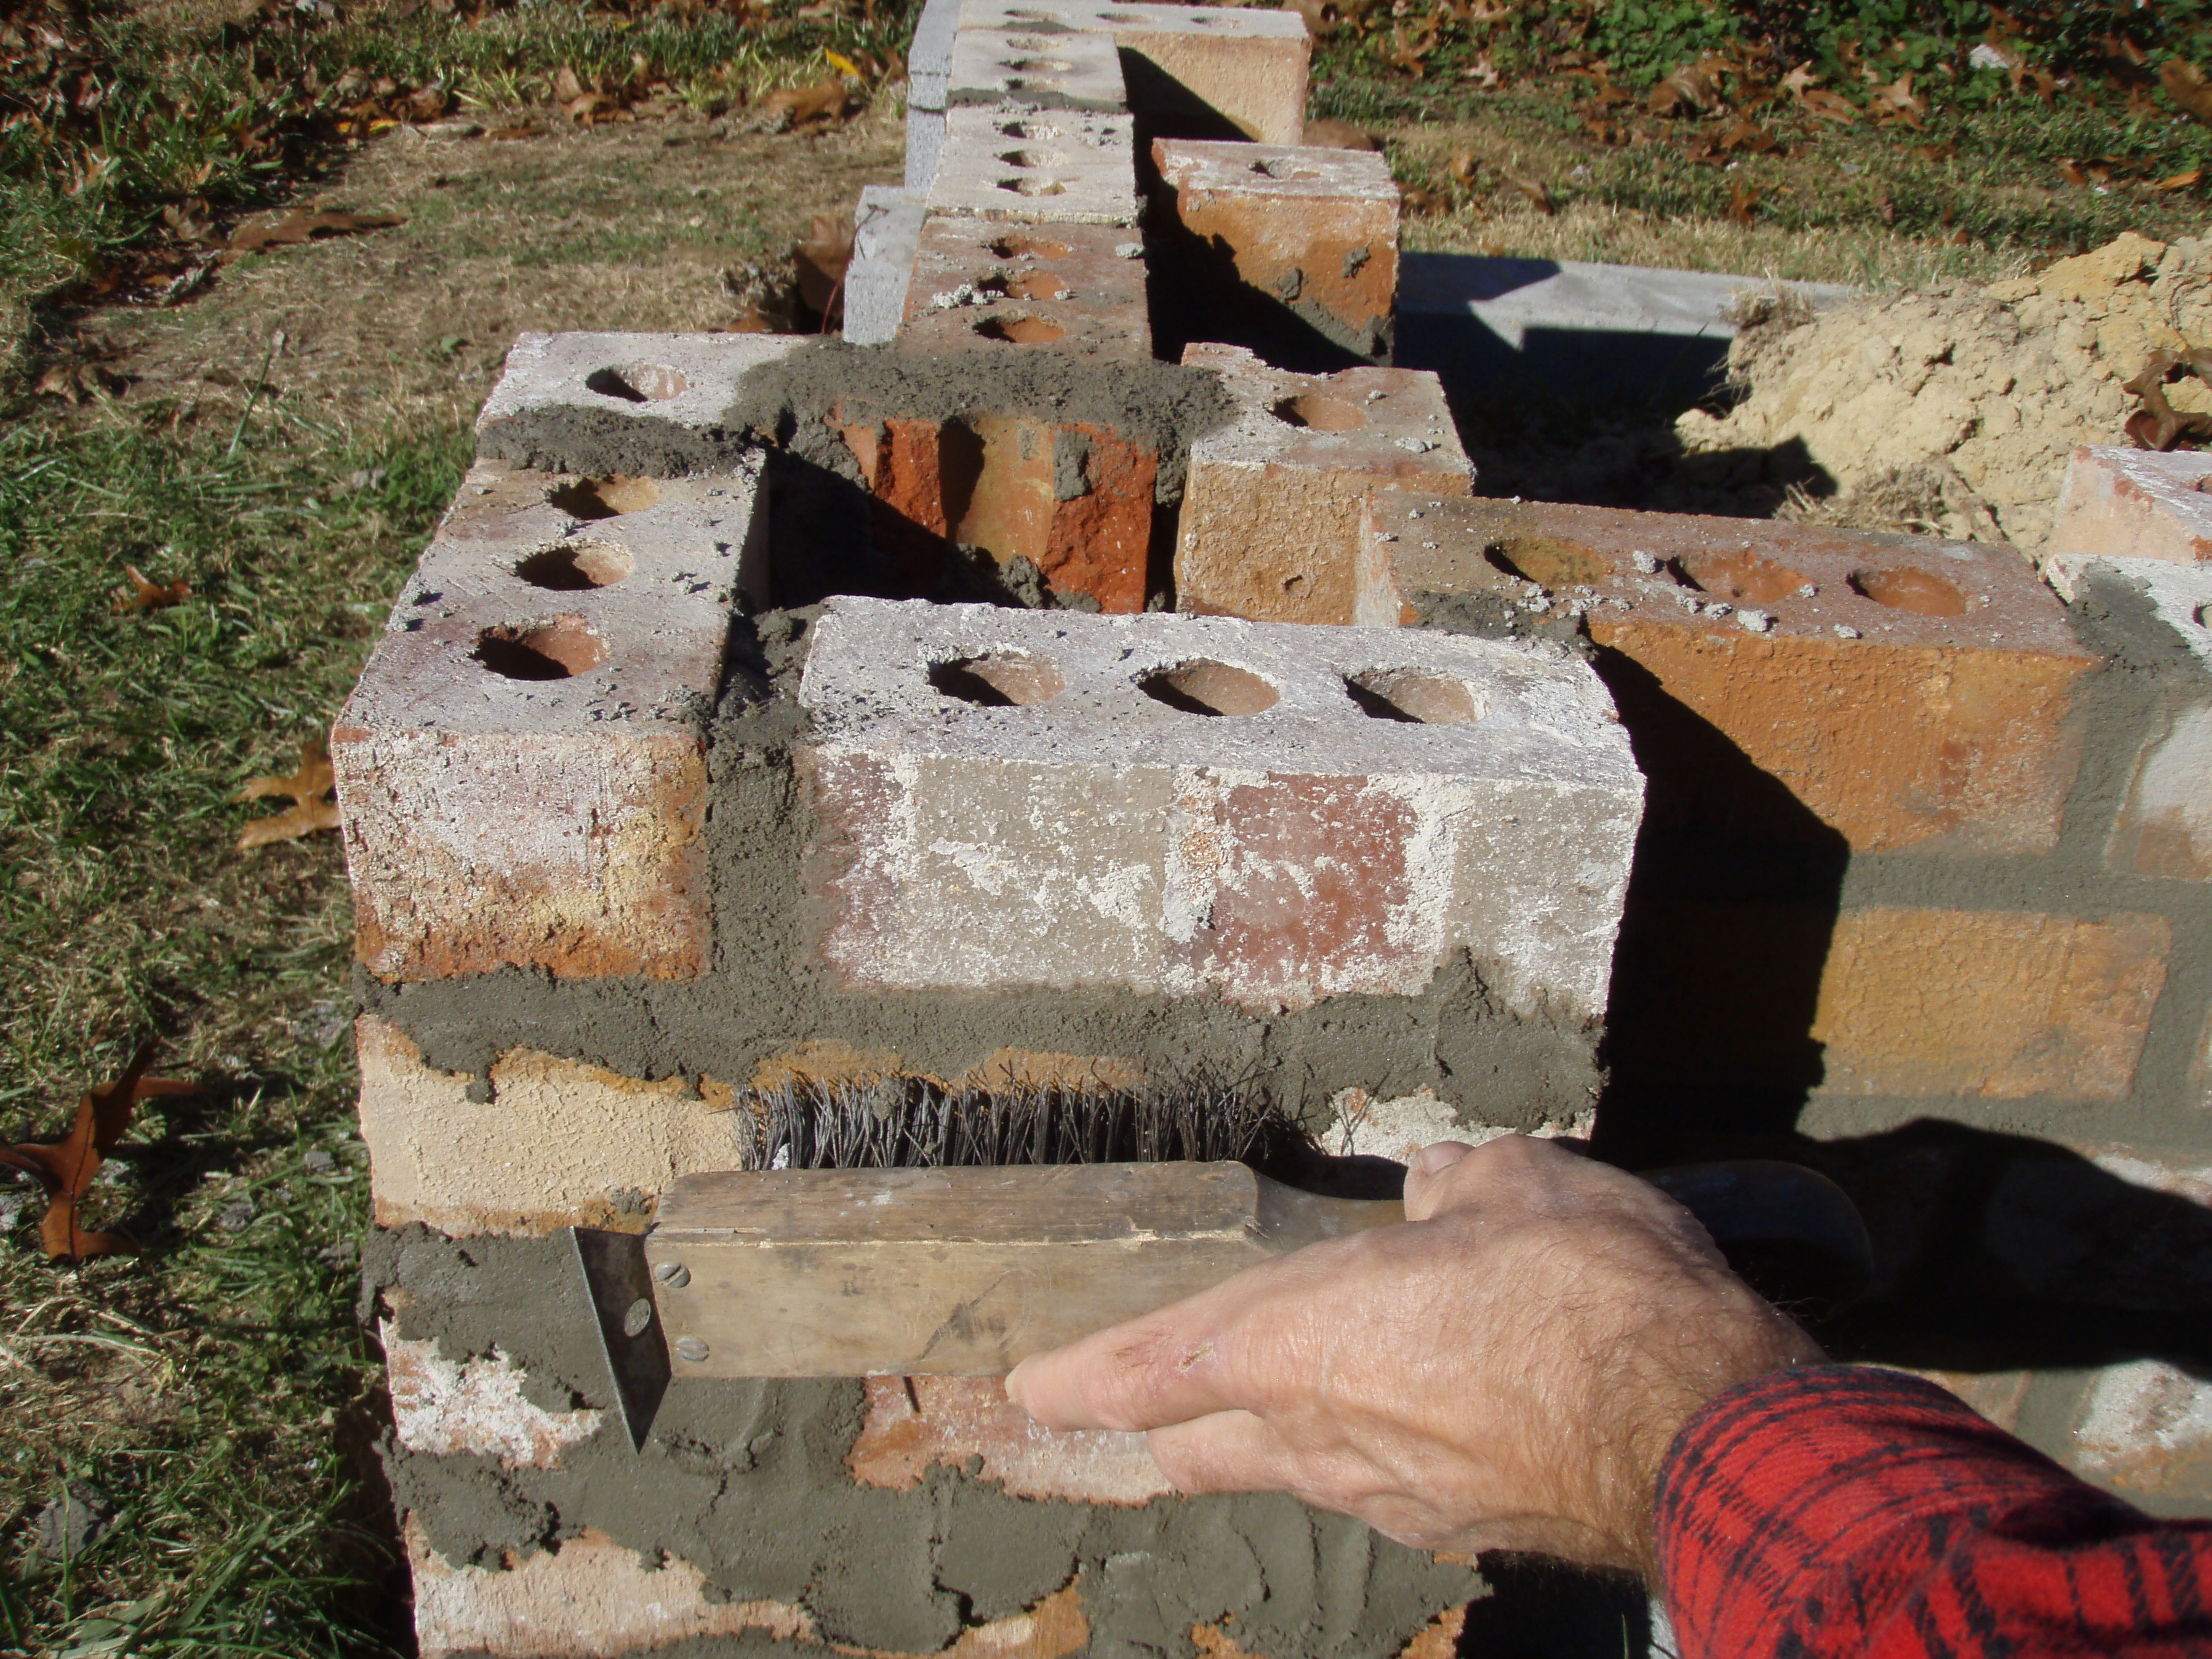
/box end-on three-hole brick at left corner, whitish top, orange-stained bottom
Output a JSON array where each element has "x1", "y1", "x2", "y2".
[{"x1": 330, "y1": 460, "x2": 768, "y2": 980}]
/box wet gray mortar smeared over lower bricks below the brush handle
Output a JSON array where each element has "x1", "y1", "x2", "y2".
[{"x1": 361, "y1": 1226, "x2": 1486, "y2": 1659}]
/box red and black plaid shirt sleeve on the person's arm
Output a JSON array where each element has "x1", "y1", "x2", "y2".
[{"x1": 1659, "y1": 1364, "x2": 2212, "y2": 1659}]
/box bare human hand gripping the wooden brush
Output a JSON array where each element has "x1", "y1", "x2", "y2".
[{"x1": 1007, "y1": 1135, "x2": 1820, "y2": 1577}]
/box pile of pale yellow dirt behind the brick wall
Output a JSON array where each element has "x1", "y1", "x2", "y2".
[{"x1": 1675, "y1": 233, "x2": 2212, "y2": 551}]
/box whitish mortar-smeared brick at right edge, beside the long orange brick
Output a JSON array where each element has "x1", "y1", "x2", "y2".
[{"x1": 2046, "y1": 555, "x2": 2212, "y2": 881}]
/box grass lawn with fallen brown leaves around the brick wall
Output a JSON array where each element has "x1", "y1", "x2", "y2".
[{"x1": 0, "y1": 0, "x2": 2212, "y2": 1659}]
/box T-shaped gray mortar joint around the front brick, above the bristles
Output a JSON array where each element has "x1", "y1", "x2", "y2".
[{"x1": 354, "y1": 611, "x2": 1601, "y2": 1128}]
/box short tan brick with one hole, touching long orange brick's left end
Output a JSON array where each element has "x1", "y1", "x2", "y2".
[{"x1": 1174, "y1": 345, "x2": 1475, "y2": 624}]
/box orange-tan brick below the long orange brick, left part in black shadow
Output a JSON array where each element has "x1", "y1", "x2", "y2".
[{"x1": 1615, "y1": 898, "x2": 2172, "y2": 1102}]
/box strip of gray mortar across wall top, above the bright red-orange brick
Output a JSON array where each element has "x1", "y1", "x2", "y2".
[{"x1": 478, "y1": 341, "x2": 1236, "y2": 506}]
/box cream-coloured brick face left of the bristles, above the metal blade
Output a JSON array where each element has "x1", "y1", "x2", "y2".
[{"x1": 354, "y1": 1013, "x2": 737, "y2": 1236}]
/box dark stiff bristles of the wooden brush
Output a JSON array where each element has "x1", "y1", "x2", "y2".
[{"x1": 739, "y1": 1077, "x2": 1312, "y2": 1170}]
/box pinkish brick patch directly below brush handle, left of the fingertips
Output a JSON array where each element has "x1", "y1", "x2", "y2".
[{"x1": 845, "y1": 1376, "x2": 1174, "y2": 1504}]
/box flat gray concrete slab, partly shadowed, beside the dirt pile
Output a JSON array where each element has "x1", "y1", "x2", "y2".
[{"x1": 1395, "y1": 254, "x2": 1853, "y2": 409}]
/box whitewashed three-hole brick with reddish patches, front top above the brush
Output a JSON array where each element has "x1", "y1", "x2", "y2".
[{"x1": 799, "y1": 600, "x2": 1641, "y2": 1024}]
